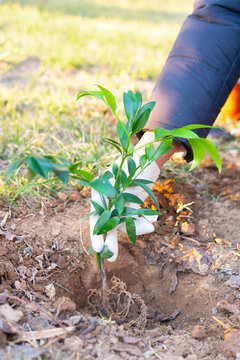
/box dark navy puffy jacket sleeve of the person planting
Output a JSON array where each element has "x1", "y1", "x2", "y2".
[{"x1": 145, "y1": 0, "x2": 240, "y2": 161}]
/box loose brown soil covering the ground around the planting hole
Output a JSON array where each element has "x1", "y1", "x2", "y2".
[{"x1": 0, "y1": 154, "x2": 240, "y2": 360}]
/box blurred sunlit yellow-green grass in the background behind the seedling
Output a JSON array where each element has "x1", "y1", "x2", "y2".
[{"x1": 0, "y1": 0, "x2": 193, "y2": 198}]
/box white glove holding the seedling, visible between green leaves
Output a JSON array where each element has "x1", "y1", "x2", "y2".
[{"x1": 90, "y1": 149, "x2": 160, "y2": 262}]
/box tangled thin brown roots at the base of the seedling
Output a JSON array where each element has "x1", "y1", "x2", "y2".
[{"x1": 88, "y1": 276, "x2": 147, "y2": 329}]
